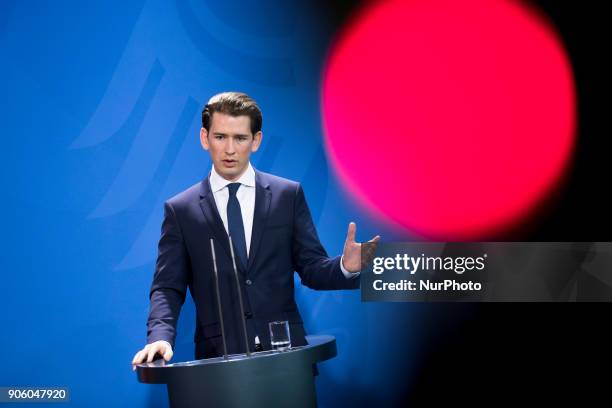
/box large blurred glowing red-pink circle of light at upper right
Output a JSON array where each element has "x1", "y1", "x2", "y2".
[{"x1": 322, "y1": 0, "x2": 576, "y2": 239}]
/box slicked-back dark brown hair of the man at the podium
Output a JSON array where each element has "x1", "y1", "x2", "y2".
[{"x1": 202, "y1": 92, "x2": 262, "y2": 135}]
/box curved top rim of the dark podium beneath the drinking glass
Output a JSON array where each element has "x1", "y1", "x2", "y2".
[{"x1": 136, "y1": 335, "x2": 337, "y2": 384}]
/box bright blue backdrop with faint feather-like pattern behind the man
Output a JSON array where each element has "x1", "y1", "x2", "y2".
[{"x1": 0, "y1": 0, "x2": 460, "y2": 407}]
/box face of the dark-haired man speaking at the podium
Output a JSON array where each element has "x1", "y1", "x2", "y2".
[{"x1": 200, "y1": 112, "x2": 262, "y2": 181}]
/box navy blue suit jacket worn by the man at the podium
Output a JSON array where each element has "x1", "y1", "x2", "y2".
[{"x1": 147, "y1": 171, "x2": 360, "y2": 359}]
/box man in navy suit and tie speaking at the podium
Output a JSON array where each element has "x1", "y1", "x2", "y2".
[{"x1": 132, "y1": 92, "x2": 380, "y2": 364}]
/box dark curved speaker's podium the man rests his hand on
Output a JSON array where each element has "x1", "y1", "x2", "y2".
[{"x1": 136, "y1": 335, "x2": 337, "y2": 408}]
